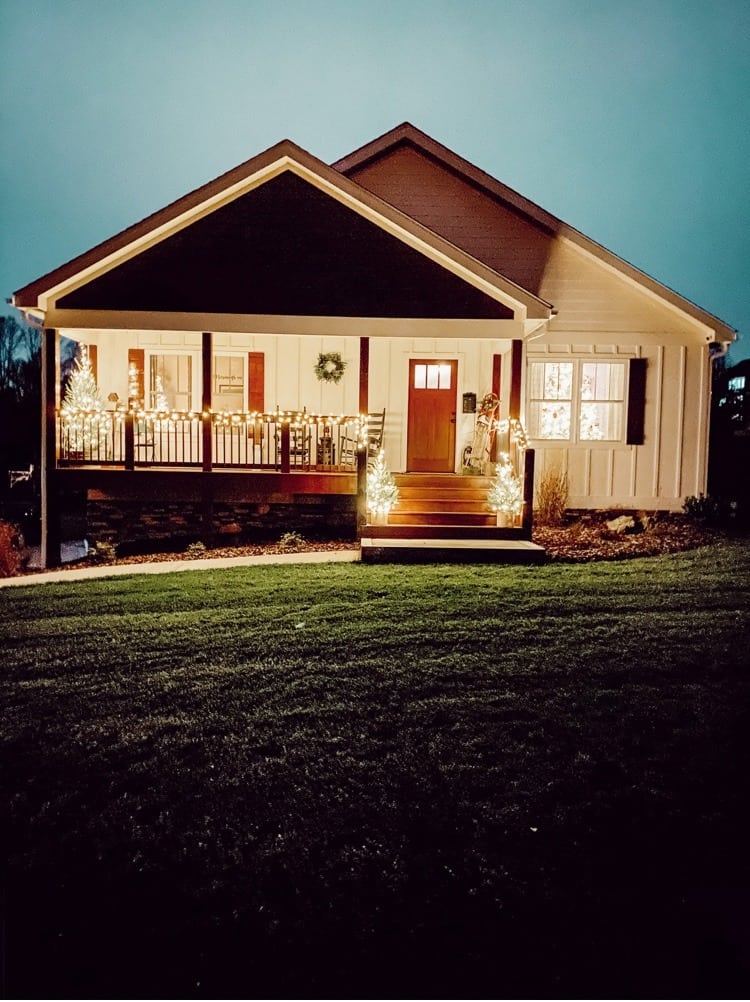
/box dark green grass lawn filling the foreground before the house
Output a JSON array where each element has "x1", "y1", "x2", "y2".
[{"x1": 0, "y1": 544, "x2": 750, "y2": 998}]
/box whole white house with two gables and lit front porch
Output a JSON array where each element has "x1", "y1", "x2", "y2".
[{"x1": 14, "y1": 124, "x2": 735, "y2": 564}]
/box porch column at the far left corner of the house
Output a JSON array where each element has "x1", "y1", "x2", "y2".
[{"x1": 40, "y1": 328, "x2": 61, "y2": 567}]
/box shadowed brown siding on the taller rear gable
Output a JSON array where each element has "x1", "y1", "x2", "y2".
[{"x1": 348, "y1": 143, "x2": 554, "y2": 295}]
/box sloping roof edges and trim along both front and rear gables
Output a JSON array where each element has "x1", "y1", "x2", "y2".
[{"x1": 13, "y1": 122, "x2": 736, "y2": 342}]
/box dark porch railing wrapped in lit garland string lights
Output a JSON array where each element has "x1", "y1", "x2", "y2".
[{"x1": 57, "y1": 408, "x2": 366, "y2": 473}]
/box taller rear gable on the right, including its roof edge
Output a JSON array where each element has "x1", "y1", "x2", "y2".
[{"x1": 333, "y1": 122, "x2": 735, "y2": 342}]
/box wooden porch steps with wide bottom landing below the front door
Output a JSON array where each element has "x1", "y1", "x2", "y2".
[{"x1": 361, "y1": 473, "x2": 546, "y2": 564}]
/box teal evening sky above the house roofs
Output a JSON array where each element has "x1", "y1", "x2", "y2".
[{"x1": 0, "y1": 0, "x2": 750, "y2": 361}]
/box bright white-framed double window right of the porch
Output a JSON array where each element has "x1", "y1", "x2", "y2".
[{"x1": 528, "y1": 361, "x2": 625, "y2": 442}]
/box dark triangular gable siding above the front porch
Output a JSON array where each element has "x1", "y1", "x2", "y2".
[{"x1": 57, "y1": 172, "x2": 513, "y2": 320}]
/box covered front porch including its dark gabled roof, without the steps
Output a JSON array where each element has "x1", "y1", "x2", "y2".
[{"x1": 15, "y1": 142, "x2": 552, "y2": 565}]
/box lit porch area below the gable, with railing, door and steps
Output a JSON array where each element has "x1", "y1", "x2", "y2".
[{"x1": 38, "y1": 331, "x2": 533, "y2": 563}]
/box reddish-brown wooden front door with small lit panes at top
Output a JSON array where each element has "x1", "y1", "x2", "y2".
[{"x1": 407, "y1": 359, "x2": 459, "y2": 473}]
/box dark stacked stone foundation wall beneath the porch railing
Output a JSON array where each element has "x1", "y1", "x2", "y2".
[{"x1": 86, "y1": 494, "x2": 356, "y2": 549}]
